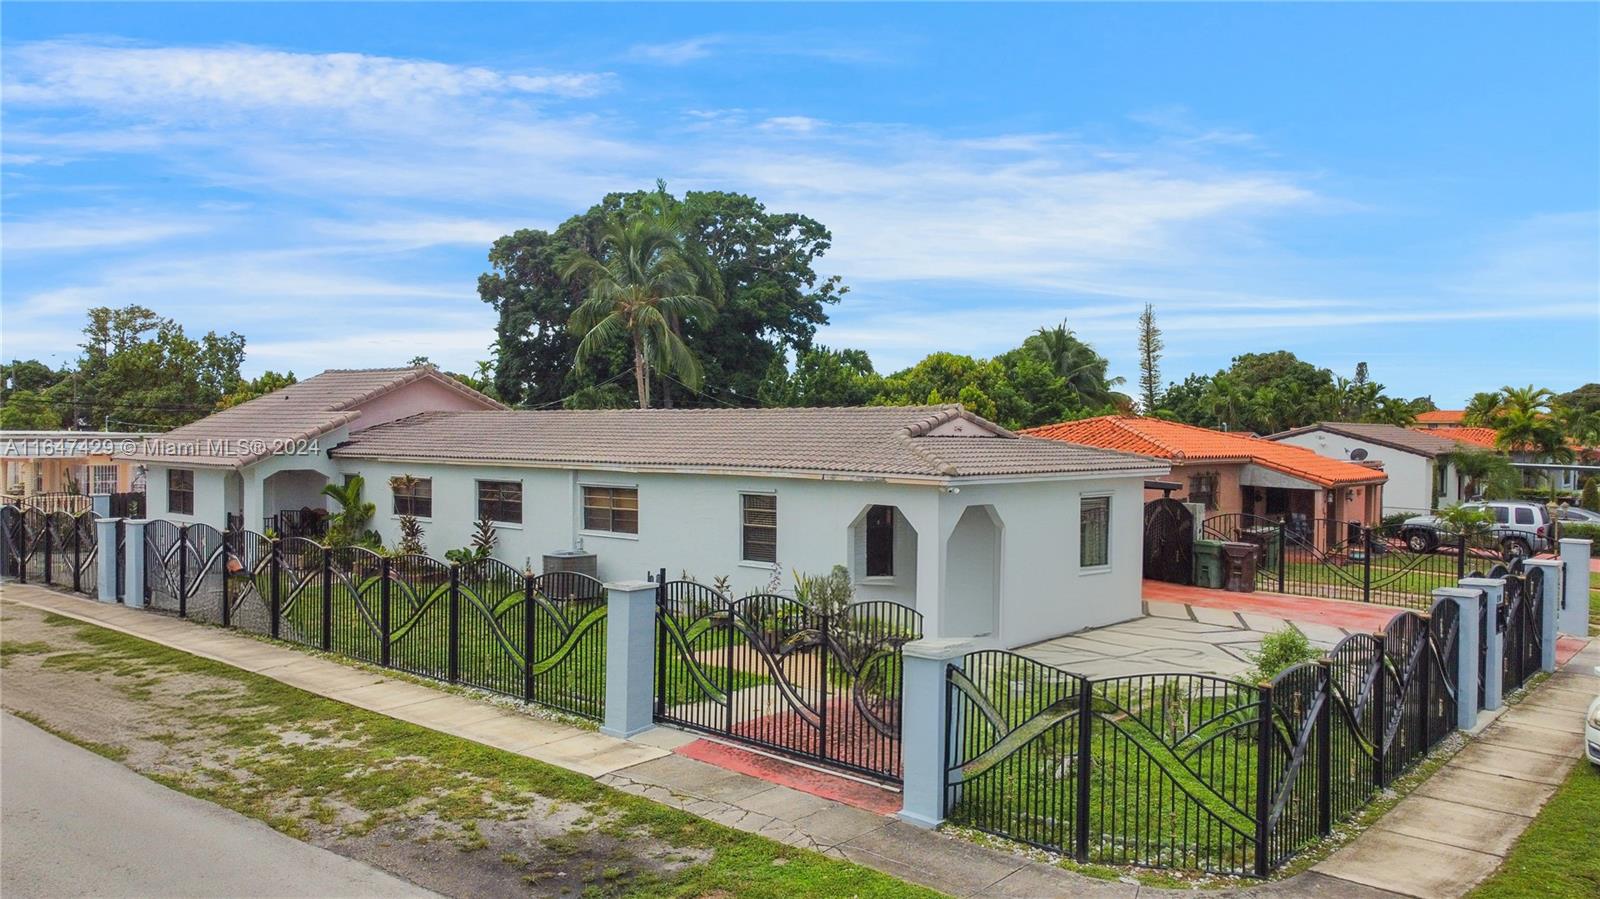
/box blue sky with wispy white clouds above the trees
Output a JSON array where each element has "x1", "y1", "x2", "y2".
[{"x1": 0, "y1": 3, "x2": 1600, "y2": 406}]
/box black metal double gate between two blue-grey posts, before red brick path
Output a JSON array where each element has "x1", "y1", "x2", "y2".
[{"x1": 654, "y1": 571, "x2": 922, "y2": 782}]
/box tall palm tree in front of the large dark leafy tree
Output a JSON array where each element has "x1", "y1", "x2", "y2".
[{"x1": 562, "y1": 213, "x2": 717, "y2": 410}]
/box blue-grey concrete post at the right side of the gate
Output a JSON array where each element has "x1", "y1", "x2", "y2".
[{"x1": 899, "y1": 640, "x2": 978, "y2": 827}]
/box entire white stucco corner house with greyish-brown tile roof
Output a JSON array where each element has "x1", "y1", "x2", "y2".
[{"x1": 118, "y1": 370, "x2": 1168, "y2": 646}]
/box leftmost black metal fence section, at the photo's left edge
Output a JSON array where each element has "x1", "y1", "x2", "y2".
[{"x1": 0, "y1": 505, "x2": 99, "y2": 595}]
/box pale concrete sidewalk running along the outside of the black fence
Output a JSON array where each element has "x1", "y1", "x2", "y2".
[{"x1": 3, "y1": 584, "x2": 1600, "y2": 897}]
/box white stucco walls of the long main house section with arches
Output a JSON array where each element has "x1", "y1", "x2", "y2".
[{"x1": 339, "y1": 459, "x2": 1144, "y2": 646}]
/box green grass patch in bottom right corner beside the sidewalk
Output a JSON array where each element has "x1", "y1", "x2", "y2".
[{"x1": 1470, "y1": 761, "x2": 1600, "y2": 899}]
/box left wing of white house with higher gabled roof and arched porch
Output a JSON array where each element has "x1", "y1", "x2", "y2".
[{"x1": 117, "y1": 366, "x2": 504, "y2": 534}]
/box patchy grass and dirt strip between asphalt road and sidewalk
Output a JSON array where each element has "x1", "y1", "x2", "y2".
[{"x1": 0, "y1": 603, "x2": 934, "y2": 897}]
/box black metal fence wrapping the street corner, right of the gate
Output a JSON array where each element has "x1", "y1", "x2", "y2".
[{"x1": 946, "y1": 600, "x2": 1459, "y2": 877}]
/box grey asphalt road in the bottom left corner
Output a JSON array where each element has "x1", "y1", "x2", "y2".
[{"x1": 0, "y1": 715, "x2": 435, "y2": 899}]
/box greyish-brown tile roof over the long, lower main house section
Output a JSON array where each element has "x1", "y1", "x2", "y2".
[{"x1": 333, "y1": 405, "x2": 1166, "y2": 480}]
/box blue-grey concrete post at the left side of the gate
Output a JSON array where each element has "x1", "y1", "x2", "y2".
[{"x1": 600, "y1": 581, "x2": 656, "y2": 737}]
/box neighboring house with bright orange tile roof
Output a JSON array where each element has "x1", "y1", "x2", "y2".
[{"x1": 1024, "y1": 416, "x2": 1387, "y2": 539}]
